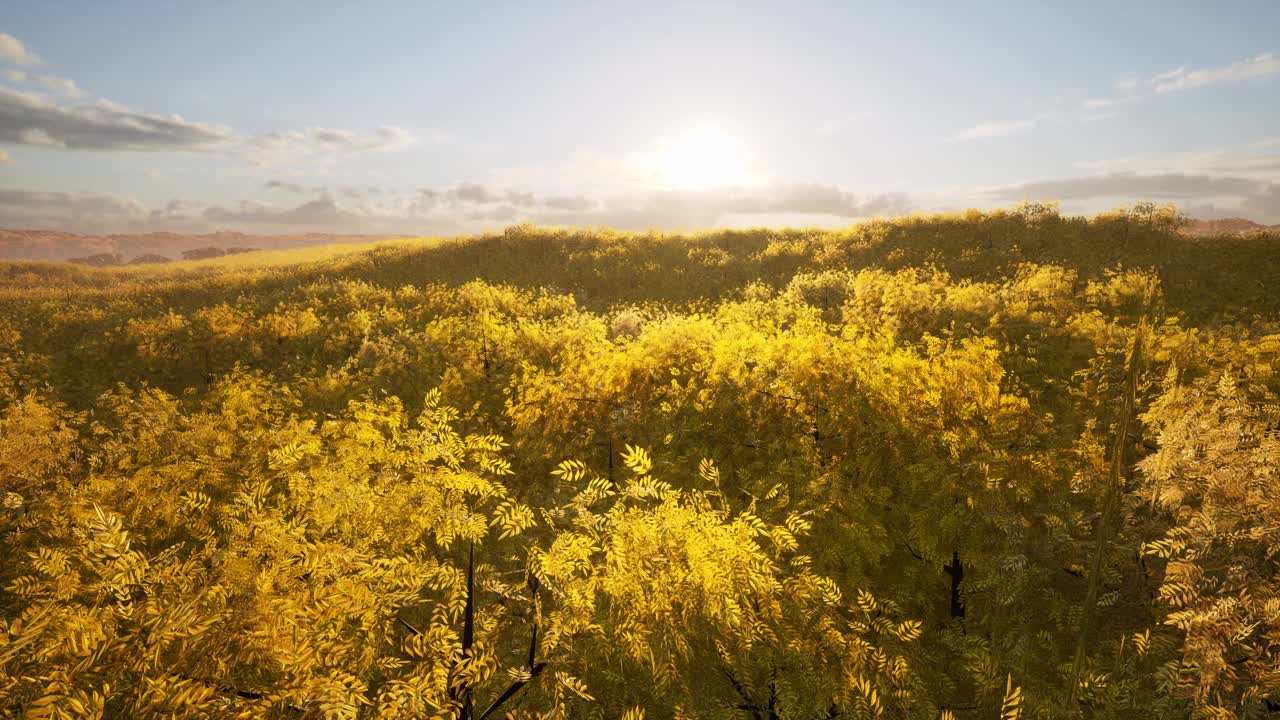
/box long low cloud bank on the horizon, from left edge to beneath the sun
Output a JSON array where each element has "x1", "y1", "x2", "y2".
[{"x1": 0, "y1": 181, "x2": 913, "y2": 234}]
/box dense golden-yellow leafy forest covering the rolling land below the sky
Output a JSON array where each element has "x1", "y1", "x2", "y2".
[{"x1": 0, "y1": 204, "x2": 1280, "y2": 720}]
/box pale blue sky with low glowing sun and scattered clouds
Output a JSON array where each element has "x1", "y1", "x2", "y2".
[{"x1": 0, "y1": 0, "x2": 1280, "y2": 234}]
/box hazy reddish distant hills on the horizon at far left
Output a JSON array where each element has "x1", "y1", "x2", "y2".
[{"x1": 0, "y1": 229, "x2": 410, "y2": 263}]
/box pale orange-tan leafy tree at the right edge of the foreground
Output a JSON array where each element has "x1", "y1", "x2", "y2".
[{"x1": 1134, "y1": 372, "x2": 1280, "y2": 698}]
